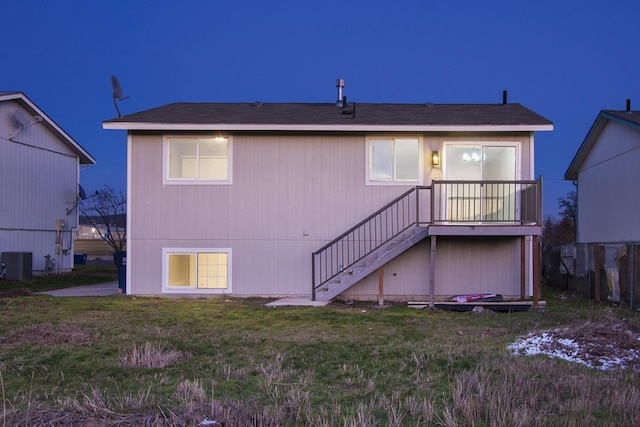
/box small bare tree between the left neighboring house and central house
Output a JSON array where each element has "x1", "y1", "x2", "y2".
[{"x1": 80, "y1": 185, "x2": 127, "y2": 252}]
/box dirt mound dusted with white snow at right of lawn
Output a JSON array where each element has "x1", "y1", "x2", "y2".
[{"x1": 507, "y1": 320, "x2": 640, "y2": 371}]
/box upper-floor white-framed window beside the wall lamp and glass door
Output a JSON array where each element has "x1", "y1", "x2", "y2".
[{"x1": 367, "y1": 136, "x2": 423, "y2": 185}]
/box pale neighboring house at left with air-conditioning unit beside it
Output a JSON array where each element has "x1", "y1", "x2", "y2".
[{"x1": 0, "y1": 92, "x2": 95, "y2": 277}]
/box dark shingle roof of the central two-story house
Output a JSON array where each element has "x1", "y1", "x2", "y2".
[{"x1": 105, "y1": 103, "x2": 552, "y2": 126}]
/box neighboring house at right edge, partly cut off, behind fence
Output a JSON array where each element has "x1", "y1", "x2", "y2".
[{"x1": 565, "y1": 101, "x2": 640, "y2": 243}]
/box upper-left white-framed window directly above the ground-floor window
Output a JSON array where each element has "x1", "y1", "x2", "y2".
[{"x1": 163, "y1": 136, "x2": 233, "y2": 185}]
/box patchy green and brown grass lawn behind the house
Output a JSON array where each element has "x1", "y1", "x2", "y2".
[{"x1": 0, "y1": 289, "x2": 640, "y2": 426}]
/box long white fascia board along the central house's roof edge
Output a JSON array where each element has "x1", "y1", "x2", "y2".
[{"x1": 102, "y1": 122, "x2": 553, "y2": 132}]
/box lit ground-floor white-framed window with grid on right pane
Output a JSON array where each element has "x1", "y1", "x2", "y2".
[{"x1": 162, "y1": 248, "x2": 231, "y2": 294}]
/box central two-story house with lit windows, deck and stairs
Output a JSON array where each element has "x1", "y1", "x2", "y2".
[{"x1": 103, "y1": 80, "x2": 553, "y2": 303}]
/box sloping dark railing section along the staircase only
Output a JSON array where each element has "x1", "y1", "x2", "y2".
[{"x1": 311, "y1": 186, "x2": 431, "y2": 301}]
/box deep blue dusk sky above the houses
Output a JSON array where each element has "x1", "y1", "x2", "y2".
[{"x1": 0, "y1": 0, "x2": 640, "y2": 214}]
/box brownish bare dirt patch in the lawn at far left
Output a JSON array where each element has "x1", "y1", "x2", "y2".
[{"x1": 0, "y1": 324, "x2": 97, "y2": 348}]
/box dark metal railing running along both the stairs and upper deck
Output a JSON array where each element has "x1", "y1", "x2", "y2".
[{"x1": 311, "y1": 180, "x2": 542, "y2": 300}]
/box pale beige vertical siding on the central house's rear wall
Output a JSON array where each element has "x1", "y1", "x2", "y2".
[{"x1": 128, "y1": 133, "x2": 530, "y2": 297}]
